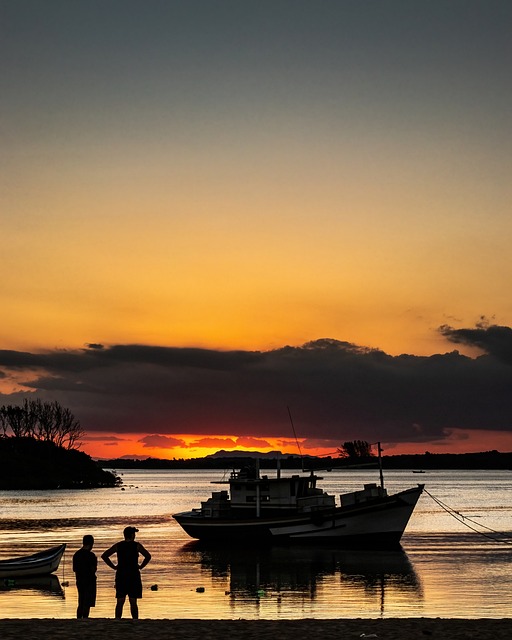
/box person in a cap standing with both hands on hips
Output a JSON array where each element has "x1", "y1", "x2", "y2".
[{"x1": 101, "y1": 527, "x2": 151, "y2": 620}]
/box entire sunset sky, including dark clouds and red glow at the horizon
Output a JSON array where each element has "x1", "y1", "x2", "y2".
[{"x1": 0, "y1": 0, "x2": 512, "y2": 458}]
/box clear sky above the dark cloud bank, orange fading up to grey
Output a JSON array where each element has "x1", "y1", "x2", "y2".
[{"x1": 0, "y1": 2, "x2": 512, "y2": 354}]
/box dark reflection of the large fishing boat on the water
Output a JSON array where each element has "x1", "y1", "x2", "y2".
[{"x1": 182, "y1": 541, "x2": 423, "y2": 612}]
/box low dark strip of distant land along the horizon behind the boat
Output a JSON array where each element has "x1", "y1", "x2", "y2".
[{"x1": 99, "y1": 451, "x2": 512, "y2": 470}]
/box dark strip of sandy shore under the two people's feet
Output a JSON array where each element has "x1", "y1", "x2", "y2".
[{"x1": 0, "y1": 618, "x2": 512, "y2": 640}]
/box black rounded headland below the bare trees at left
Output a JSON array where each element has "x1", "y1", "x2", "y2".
[{"x1": 0, "y1": 437, "x2": 120, "y2": 489}]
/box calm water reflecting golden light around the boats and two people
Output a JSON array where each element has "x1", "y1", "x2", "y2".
[{"x1": 0, "y1": 470, "x2": 512, "y2": 619}]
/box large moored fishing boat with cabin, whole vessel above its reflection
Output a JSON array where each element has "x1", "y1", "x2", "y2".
[{"x1": 173, "y1": 467, "x2": 424, "y2": 548}]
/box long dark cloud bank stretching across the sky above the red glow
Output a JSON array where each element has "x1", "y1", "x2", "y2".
[{"x1": 0, "y1": 323, "x2": 512, "y2": 446}]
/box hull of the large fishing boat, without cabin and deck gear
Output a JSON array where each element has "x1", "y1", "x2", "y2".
[{"x1": 173, "y1": 485, "x2": 423, "y2": 548}]
